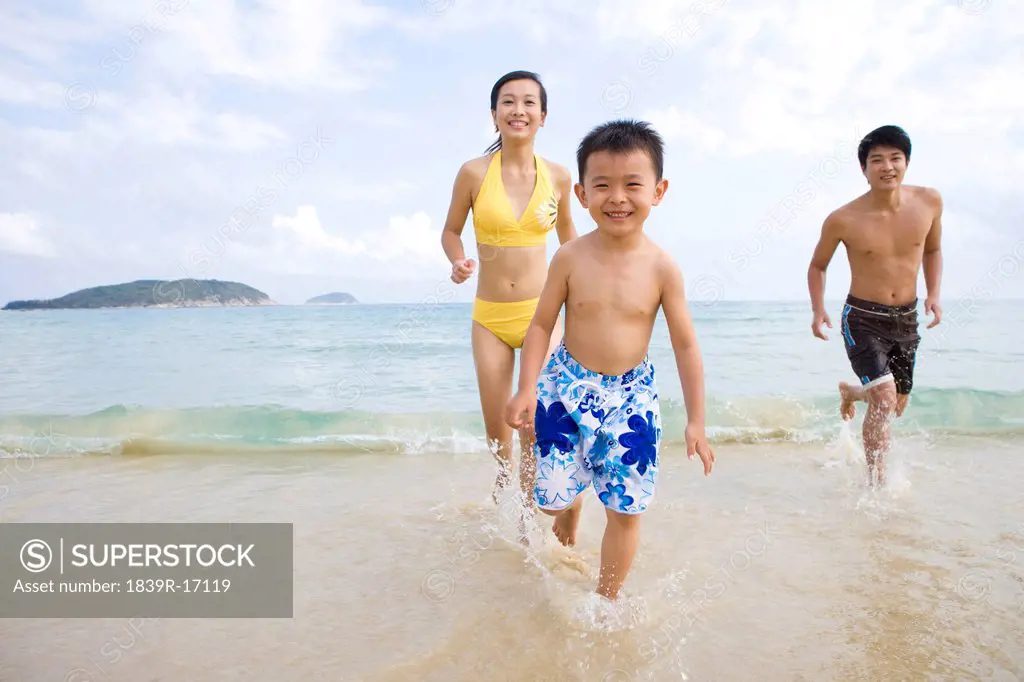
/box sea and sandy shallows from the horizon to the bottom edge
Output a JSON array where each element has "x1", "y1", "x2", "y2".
[{"x1": 0, "y1": 298, "x2": 1024, "y2": 682}]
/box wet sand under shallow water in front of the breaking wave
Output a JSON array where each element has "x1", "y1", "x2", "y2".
[{"x1": 0, "y1": 433, "x2": 1024, "y2": 682}]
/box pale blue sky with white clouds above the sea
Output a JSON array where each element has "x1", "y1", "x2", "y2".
[{"x1": 0, "y1": 0, "x2": 1024, "y2": 308}]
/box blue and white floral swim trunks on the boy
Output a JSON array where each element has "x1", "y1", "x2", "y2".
[{"x1": 534, "y1": 343, "x2": 662, "y2": 514}]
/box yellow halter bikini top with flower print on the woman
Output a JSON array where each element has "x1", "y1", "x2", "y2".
[{"x1": 473, "y1": 151, "x2": 558, "y2": 247}]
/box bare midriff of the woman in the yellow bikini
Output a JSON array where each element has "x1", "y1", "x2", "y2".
[{"x1": 476, "y1": 244, "x2": 548, "y2": 303}]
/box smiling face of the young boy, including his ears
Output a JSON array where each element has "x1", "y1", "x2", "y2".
[{"x1": 575, "y1": 150, "x2": 669, "y2": 237}]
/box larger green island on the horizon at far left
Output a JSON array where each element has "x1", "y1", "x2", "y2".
[{"x1": 2, "y1": 280, "x2": 275, "y2": 310}]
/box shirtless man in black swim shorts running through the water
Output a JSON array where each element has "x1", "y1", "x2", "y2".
[{"x1": 807, "y1": 126, "x2": 942, "y2": 484}]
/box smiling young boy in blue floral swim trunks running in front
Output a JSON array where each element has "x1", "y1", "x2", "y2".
[{"x1": 506, "y1": 121, "x2": 715, "y2": 600}]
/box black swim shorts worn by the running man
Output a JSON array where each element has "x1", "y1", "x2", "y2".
[{"x1": 843, "y1": 296, "x2": 921, "y2": 395}]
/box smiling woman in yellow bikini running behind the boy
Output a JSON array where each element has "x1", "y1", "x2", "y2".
[{"x1": 441, "y1": 71, "x2": 577, "y2": 507}]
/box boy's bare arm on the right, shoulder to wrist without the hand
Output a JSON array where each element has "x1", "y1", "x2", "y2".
[{"x1": 660, "y1": 254, "x2": 705, "y2": 428}]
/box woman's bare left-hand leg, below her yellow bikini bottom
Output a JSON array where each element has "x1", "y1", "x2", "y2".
[{"x1": 472, "y1": 321, "x2": 515, "y2": 504}]
